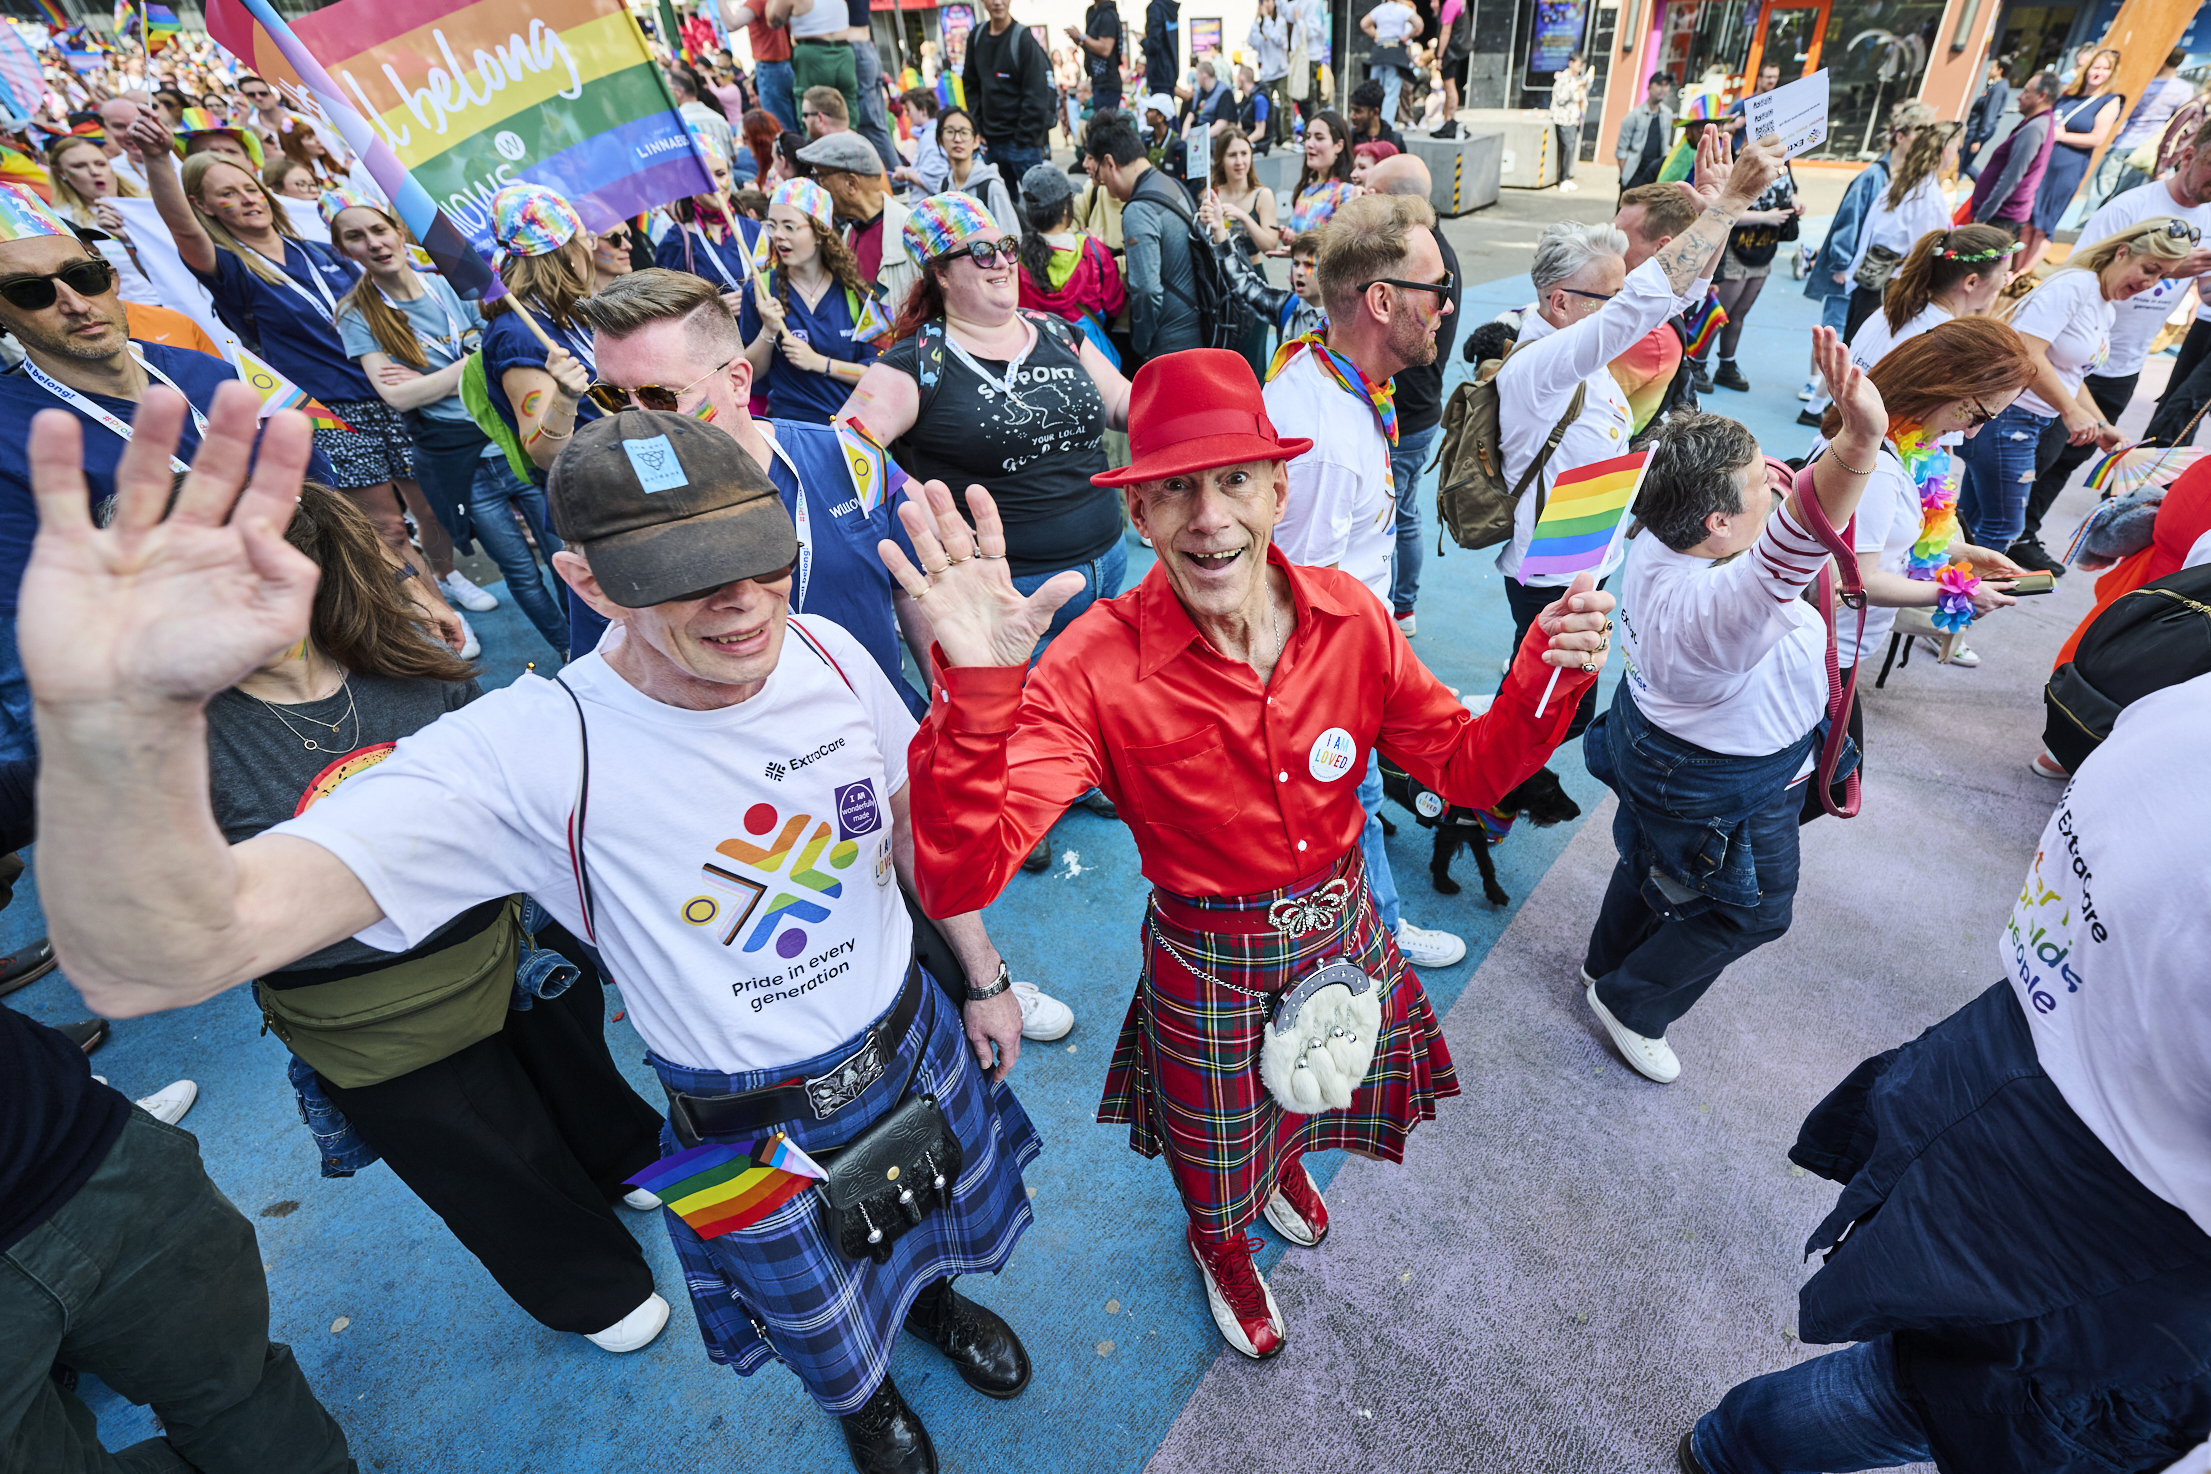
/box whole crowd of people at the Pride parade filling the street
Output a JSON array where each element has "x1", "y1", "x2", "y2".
[{"x1": 0, "y1": 11, "x2": 2211, "y2": 1474}]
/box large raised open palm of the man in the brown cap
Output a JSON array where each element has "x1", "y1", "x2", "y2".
[{"x1": 18, "y1": 382, "x2": 318, "y2": 709}]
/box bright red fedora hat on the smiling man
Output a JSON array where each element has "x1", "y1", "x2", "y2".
[{"x1": 1090, "y1": 347, "x2": 1313, "y2": 486}]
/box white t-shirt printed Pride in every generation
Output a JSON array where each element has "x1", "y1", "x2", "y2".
[{"x1": 270, "y1": 617, "x2": 915, "y2": 1074}]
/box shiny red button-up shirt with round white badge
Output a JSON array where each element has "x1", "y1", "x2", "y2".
[{"x1": 907, "y1": 548, "x2": 1596, "y2": 917}]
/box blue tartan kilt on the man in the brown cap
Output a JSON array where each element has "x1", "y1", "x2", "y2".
[{"x1": 646, "y1": 979, "x2": 1044, "y2": 1417}]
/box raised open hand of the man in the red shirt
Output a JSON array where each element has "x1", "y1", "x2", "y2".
[{"x1": 876, "y1": 482, "x2": 1083, "y2": 665}]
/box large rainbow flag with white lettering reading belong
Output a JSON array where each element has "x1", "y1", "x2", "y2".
[{"x1": 206, "y1": 0, "x2": 714, "y2": 296}]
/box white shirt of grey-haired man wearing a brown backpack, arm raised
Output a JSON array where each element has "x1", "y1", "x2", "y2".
[{"x1": 1503, "y1": 259, "x2": 1705, "y2": 588}]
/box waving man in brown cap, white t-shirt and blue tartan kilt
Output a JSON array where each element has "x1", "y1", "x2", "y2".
[{"x1": 22, "y1": 384, "x2": 1041, "y2": 1474}]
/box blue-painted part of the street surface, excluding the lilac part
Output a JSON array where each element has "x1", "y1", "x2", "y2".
[{"x1": 0, "y1": 256, "x2": 1815, "y2": 1474}]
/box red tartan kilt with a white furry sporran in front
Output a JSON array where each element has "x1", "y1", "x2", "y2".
[{"x1": 1099, "y1": 849, "x2": 1459, "y2": 1238}]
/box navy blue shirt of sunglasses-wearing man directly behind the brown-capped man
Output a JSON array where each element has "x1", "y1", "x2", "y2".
[{"x1": 568, "y1": 420, "x2": 929, "y2": 720}]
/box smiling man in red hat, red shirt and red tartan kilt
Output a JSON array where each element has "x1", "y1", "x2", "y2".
[{"x1": 880, "y1": 349, "x2": 1612, "y2": 1357}]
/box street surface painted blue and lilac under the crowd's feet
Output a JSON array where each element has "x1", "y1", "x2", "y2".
[{"x1": 0, "y1": 179, "x2": 2171, "y2": 1474}]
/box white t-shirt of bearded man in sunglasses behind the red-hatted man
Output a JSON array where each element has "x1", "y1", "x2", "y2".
[{"x1": 1265, "y1": 349, "x2": 1397, "y2": 608}]
